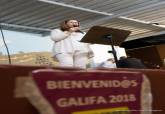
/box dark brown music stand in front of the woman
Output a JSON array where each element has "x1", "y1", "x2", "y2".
[{"x1": 81, "y1": 26, "x2": 131, "y2": 63}]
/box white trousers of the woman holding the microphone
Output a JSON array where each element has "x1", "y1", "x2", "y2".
[{"x1": 56, "y1": 52, "x2": 88, "y2": 68}]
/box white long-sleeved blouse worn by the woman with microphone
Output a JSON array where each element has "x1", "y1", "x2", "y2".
[{"x1": 51, "y1": 29, "x2": 91, "y2": 55}]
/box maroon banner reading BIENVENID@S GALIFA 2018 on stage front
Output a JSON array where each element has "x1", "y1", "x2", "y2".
[{"x1": 15, "y1": 70, "x2": 152, "y2": 114}]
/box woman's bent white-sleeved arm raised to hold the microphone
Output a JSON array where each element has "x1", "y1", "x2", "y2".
[{"x1": 51, "y1": 29, "x2": 70, "y2": 42}]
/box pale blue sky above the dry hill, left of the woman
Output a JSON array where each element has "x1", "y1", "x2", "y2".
[{"x1": 0, "y1": 30, "x2": 53, "y2": 54}]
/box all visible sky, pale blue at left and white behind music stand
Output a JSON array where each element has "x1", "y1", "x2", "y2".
[{"x1": 0, "y1": 30, "x2": 126, "y2": 63}]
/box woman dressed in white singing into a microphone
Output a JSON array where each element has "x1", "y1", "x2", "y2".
[{"x1": 51, "y1": 20, "x2": 93, "y2": 68}]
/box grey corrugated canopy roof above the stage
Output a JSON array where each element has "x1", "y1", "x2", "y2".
[{"x1": 0, "y1": 0, "x2": 165, "y2": 40}]
